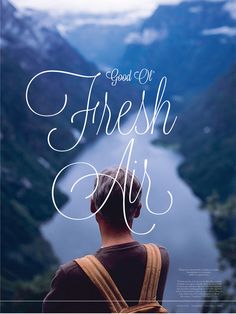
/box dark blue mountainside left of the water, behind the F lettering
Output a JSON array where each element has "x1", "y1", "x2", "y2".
[{"x1": 0, "y1": 0, "x2": 136, "y2": 312}]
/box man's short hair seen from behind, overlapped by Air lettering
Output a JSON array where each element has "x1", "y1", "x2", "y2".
[{"x1": 93, "y1": 167, "x2": 142, "y2": 227}]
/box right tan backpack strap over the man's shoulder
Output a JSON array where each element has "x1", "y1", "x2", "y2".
[{"x1": 139, "y1": 243, "x2": 161, "y2": 304}]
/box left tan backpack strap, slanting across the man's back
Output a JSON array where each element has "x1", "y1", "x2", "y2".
[{"x1": 74, "y1": 255, "x2": 127, "y2": 313}]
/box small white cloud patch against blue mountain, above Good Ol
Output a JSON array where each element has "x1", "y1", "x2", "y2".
[{"x1": 125, "y1": 28, "x2": 167, "y2": 45}]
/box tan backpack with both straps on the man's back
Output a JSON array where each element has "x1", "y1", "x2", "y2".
[{"x1": 74, "y1": 243, "x2": 167, "y2": 313}]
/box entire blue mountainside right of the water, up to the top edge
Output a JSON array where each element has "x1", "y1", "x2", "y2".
[{"x1": 136, "y1": 0, "x2": 236, "y2": 306}]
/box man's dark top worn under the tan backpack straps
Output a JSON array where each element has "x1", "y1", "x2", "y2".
[{"x1": 43, "y1": 241, "x2": 169, "y2": 313}]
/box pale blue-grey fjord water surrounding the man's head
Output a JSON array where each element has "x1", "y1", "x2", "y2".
[{"x1": 42, "y1": 110, "x2": 223, "y2": 312}]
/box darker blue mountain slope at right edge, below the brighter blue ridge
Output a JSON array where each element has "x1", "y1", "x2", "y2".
[{"x1": 171, "y1": 64, "x2": 236, "y2": 201}]
